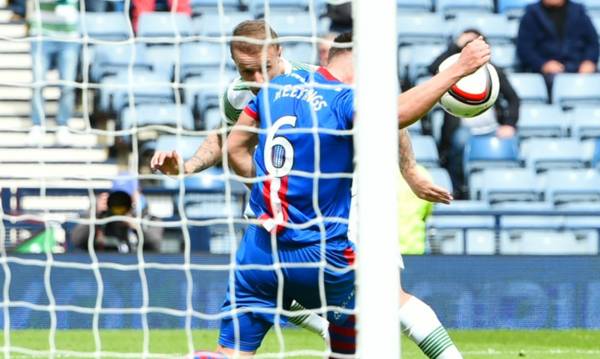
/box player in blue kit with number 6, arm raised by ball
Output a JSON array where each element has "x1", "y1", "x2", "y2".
[{"x1": 200, "y1": 35, "x2": 490, "y2": 358}]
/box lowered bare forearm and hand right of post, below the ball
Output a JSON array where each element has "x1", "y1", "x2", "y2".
[{"x1": 398, "y1": 128, "x2": 452, "y2": 204}]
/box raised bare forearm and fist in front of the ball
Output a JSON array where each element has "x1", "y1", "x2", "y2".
[{"x1": 398, "y1": 38, "x2": 491, "y2": 128}]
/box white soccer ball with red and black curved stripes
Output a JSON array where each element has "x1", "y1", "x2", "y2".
[{"x1": 439, "y1": 54, "x2": 500, "y2": 117}]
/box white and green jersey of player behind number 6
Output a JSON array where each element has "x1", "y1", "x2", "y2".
[{"x1": 223, "y1": 58, "x2": 317, "y2": 127}]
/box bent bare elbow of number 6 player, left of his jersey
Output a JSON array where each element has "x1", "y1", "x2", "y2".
[{"x1": 227, "y1": 112, "x2": 258, "y2": 178}]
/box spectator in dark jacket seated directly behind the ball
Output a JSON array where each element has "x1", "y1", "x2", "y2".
[{"x1": 429, "y1": 29, "x2": 520, "y2": 199}]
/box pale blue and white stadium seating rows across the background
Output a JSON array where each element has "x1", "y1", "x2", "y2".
[{"x1": 0, "y1": 0, "x2": 600, "y2": 254}]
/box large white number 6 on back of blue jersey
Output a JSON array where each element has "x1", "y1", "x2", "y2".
[{"x1": 264, "y1": 116, "x2": 296, "y2": 177}]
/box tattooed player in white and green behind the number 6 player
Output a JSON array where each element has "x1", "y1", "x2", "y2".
[{"x1": 151, "y1": 20, "x2": 451, "y2": 352}]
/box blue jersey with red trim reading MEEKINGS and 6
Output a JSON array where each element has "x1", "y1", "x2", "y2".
[{"x1": 244, "y1": 68, "x2": 354, "y2": 243}]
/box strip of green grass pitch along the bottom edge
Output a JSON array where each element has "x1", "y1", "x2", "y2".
[{"x1": 0, "y1": 329, "x2": 600, "y2": 359}]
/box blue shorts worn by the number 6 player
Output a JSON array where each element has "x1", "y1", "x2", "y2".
[{"x1": 219, "y1": 226, "x2": 355, "y2": 352}]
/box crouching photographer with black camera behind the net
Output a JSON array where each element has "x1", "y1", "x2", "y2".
[{"x1": 71, "y1": 176, "x2": 163, "y2": 253}]
